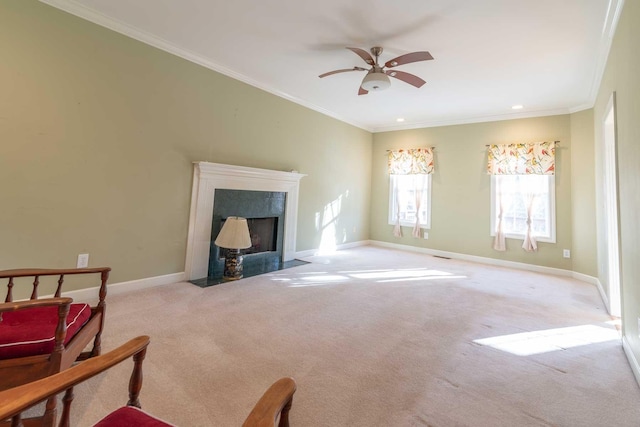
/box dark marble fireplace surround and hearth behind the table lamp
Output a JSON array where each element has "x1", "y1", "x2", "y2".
[{"x1": 192, "y1": 189, "x2": 304, "y2": 286}]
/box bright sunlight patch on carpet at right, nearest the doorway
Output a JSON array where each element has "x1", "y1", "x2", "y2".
[{"x1": 473, "y1": 325, "x2": 620, "y2": 356}]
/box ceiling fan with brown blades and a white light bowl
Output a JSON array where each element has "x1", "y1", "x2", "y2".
[{"x1": 318, "y1": 46, "x2": 433, "y2": 95}]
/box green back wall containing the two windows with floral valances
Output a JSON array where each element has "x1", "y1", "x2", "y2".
[{"x1": 371, "y1": 113, "x2": 584, "y2": 273}]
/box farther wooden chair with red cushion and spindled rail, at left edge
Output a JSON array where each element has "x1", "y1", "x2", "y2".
[{"x1": 0, "y1": 267, "x2": 111, "y2": 426}]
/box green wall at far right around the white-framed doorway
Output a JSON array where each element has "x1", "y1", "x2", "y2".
[{"x1": 594, "y1": 0, "x2": 640, "y2": 372}]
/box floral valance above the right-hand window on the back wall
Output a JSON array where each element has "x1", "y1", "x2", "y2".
[{"x1": 487, "y1": 142, "x2": 556, "y2": 175}]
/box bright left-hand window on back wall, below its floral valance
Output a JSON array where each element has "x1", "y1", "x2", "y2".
[{"x1": 389, "y1": 174, "x2": 431, "y2": 228}]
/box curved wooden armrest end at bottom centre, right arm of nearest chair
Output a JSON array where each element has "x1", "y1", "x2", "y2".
[{"x1": 242, "y1": 377, "x2": 296, "y2": 427}]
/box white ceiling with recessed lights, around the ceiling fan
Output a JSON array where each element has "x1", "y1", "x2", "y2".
[{"x1": 41, "y1": 0, "x2": 622, "y2": 132}]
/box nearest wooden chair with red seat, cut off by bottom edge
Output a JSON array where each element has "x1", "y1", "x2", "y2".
[{"x1": 0, "y1": 336, "x2": 296, "y2": 427}]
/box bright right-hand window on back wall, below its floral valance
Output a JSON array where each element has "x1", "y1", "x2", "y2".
[{"x1": 491, "y1": 175, "x2": 556, "y2": 243}]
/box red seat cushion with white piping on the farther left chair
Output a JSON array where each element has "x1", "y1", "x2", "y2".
[{"x1": 0, "y1": 304, "x2": 91, "y2": 359}]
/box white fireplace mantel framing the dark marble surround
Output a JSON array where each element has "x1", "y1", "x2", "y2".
[{"x1": 184, "y1": 162, "x2": 306, "y2": 280}]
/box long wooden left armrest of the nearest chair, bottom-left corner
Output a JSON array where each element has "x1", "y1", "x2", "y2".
[{"x1": 0, "y1": 335, "x2": 149, "y2": 420}]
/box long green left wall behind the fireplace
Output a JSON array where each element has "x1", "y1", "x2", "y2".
[{"x1": 0, "y1": 0, "x2": 372, "y2": 290}]
